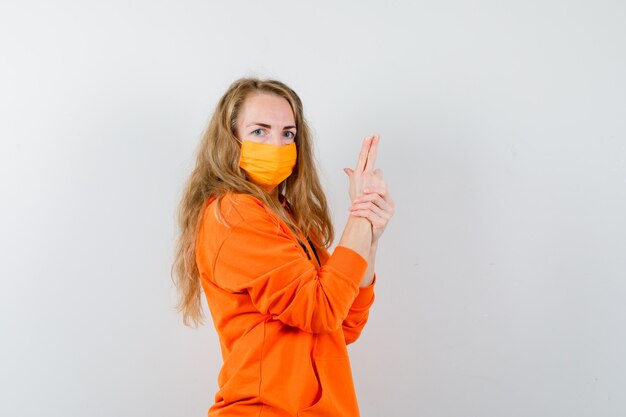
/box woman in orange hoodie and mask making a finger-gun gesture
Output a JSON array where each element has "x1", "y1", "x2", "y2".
[{"x1": 174, "y1": 78, "x2": 394, "y2": 417}]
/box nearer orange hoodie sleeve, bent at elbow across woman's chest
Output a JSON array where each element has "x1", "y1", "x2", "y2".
[{"x1": 213, "y1": 196, "x2": 367, "y2": 333}]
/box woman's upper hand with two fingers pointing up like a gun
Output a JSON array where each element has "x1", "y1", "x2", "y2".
[{"x1": 343, "y1": 134, "x2": 384, "y2": 201}]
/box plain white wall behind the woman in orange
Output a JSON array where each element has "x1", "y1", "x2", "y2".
[{"x1": 0, "y1": 0, "x2": 626, "y2": 417}]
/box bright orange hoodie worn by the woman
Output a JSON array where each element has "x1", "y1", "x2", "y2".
[{"x1": 196, "y1": 194, "x2": 374, "y2": 417}]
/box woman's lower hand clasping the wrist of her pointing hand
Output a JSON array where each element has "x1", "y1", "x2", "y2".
[{"x1": 350, "y1": 179, "x2": 396, "y2": 243}]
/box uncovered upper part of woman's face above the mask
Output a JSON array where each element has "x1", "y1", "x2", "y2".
[{"x1": 237, "y1": 93, "x2": 296, "y2": 146}]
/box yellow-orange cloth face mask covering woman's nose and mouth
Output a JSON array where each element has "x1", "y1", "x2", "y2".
[{"x1": 239, "y1": 140, "x2": 297, "y2": 192}]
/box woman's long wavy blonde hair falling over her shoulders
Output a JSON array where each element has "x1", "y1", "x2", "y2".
[{"x1": 172, "y1": 78, "x2": 334, "y2": 326}]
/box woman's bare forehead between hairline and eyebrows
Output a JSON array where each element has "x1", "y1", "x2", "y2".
[{"x1": 239, "y1": 93, "x2": 295, "y2": 123}]
